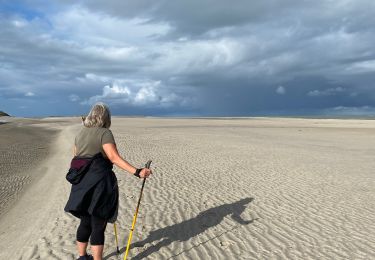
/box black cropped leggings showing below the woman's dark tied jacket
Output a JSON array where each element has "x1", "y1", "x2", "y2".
[{"x1": 77, "y1": 216, "x2": 107, "y2": 246}]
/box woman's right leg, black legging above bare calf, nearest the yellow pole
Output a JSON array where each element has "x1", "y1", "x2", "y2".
[{"x1": 90, "y1": 216, "x2": 107, "y2": 260}]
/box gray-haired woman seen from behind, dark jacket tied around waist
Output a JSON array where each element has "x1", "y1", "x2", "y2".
[{"x1": 65, "y1": 103, "x2": 152, "y2": 260}]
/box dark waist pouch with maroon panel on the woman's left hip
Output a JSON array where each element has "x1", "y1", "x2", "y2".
[{"x1": 65, "y1": 153, "x2": 103, "y2": 184}]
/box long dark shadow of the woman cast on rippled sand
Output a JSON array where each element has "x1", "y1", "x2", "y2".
[{"x1": 104, "y1": 198, "x2": 254, "y2": 259}]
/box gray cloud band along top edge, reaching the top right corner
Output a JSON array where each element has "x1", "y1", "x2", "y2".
[{"x1": 62, "y1": 0, "x2": 375, "y2": 35}]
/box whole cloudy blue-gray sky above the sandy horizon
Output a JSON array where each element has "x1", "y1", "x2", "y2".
[{"x1": 0, "y1": 0, "x2": 375, "y2": 117}]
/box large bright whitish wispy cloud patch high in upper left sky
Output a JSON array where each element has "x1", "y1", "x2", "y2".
[{"x1": 50, "y1": 5, "x2": 170, "y2": 47}]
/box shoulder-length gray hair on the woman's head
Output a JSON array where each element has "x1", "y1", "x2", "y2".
[{"x1": 83, "y1": 102, "x2": 111, "y2": 128}]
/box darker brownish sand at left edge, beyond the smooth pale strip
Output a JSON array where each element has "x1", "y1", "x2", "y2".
[{"x1": 0, "y1": 117, "x2": 58, "y2": 218}]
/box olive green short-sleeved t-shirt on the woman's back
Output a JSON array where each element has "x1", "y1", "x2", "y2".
[{"x1": 74, "y1": 126, "x2": 115, "y2": 157}]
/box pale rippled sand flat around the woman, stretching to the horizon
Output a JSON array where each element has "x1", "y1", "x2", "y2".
[{"x1": 0, "y1": 118, "x2": 375, "y2": 259}]
